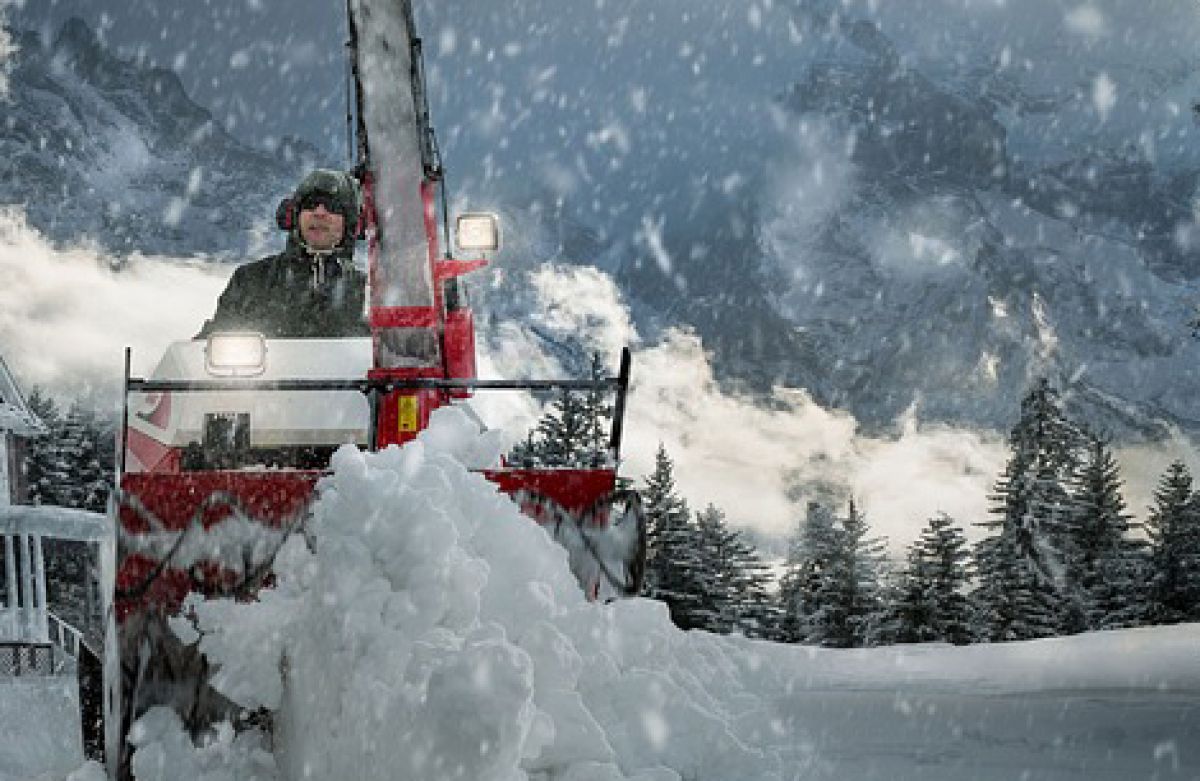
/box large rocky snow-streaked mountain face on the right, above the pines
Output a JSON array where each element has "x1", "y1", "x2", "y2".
[{"x1": 624, "y1": 16, "x2": 1200, "y2": 438}]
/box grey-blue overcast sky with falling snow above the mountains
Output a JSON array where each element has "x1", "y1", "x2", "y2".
[{"x1": 11, "y1": 0, "x2": 1200, "y2": 238}]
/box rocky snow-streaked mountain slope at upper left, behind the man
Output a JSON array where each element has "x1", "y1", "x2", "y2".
[{"x1": 0, "y1": 19, "x2": 317, "y2": 257}]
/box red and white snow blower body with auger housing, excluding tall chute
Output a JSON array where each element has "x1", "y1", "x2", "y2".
[{"x1": 106, "y1": 345, "x2": 646, "y2": 777}]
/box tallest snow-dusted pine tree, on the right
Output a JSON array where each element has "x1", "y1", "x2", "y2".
[{"x1": 973, "y1": 379, "x2": 1082, "y2": 641}]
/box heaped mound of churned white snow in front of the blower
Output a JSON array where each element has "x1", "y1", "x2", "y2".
[{"x1": 131, "y1": 409, "x2": 780, "y2": 781}]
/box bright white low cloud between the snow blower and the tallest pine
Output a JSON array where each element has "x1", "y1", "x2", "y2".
[{"x1": 480, "y1": 265, "x2": 1004, "y2": 549}]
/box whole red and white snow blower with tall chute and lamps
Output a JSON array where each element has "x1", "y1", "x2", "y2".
[{"x1": 104, "y1": 0, "x2": 646, "y2": 779}]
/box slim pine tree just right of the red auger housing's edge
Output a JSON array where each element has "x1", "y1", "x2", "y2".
[{"x1": 642, "y1": 444, "x2": 706, "y2": 629}]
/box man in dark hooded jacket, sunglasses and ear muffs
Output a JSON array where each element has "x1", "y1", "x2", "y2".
[{"x1": 196, "y1": 168, "x2": 371, "y2": 340}]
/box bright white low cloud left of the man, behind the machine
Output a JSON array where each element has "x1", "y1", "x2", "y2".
[{"x1": 0, "y1": 209, "x2": 229, "y2": 395}]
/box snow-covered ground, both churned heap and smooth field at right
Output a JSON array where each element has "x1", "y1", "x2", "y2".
[{"x1": 63, "y1": 410, "x2": 1200, "y2": 781}]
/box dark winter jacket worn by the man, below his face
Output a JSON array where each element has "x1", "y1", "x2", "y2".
[{"x1": 196, "y1": 240, "x2": 371, "y2": 338}]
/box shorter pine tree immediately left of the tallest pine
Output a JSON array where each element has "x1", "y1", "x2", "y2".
[{"x1": 895, "y1": 513, "x2": 971, "y2": 644}]
